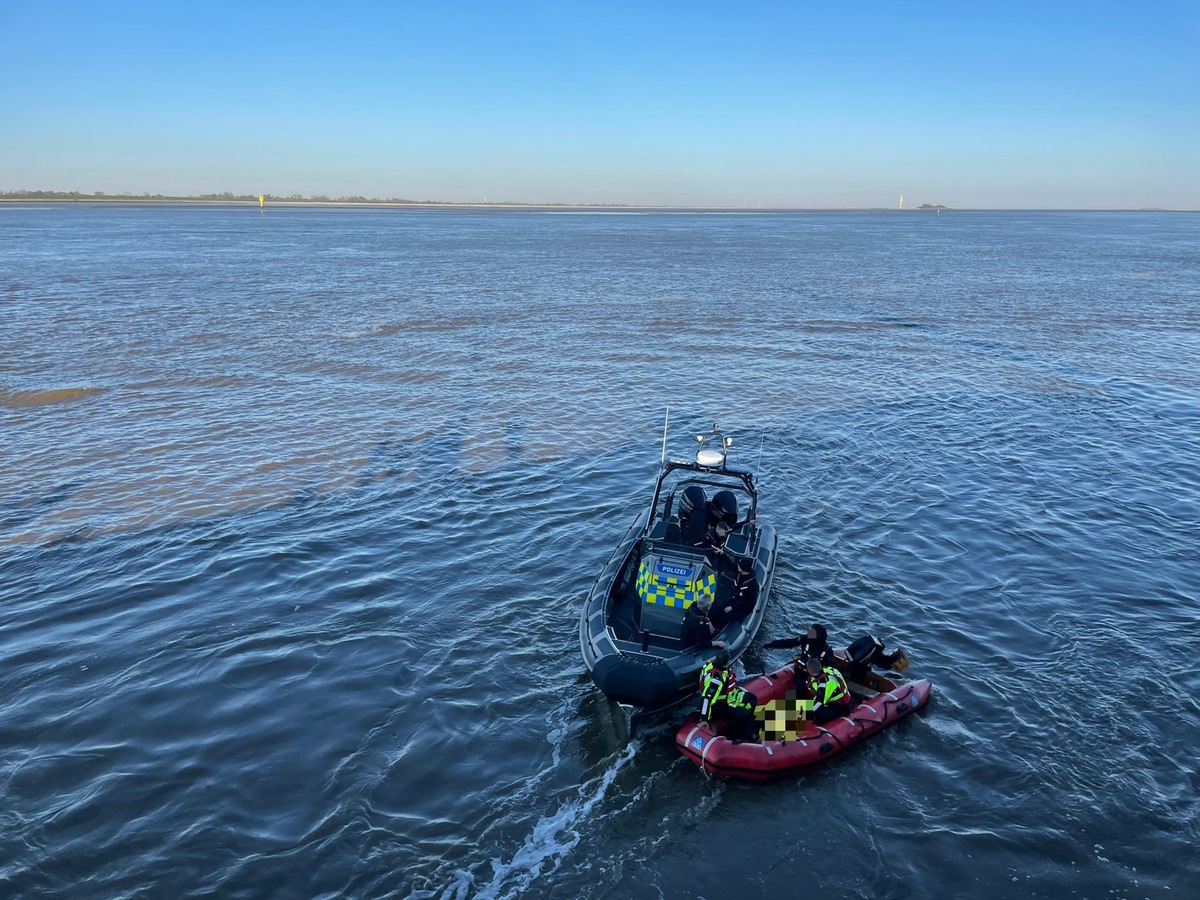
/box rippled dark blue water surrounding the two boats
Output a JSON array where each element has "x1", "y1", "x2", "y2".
[{"x1": 0, "y1": 206, "x2": 1200, "y2": 900}]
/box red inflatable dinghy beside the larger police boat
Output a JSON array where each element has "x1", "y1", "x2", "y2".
[{"x1": 676, "y1": 666, "x2": 932, "y2": 781}]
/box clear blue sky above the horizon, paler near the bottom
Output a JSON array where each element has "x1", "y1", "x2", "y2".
[{"x1": 0, "y1": 0, "x2": 1200, "y2": 209}]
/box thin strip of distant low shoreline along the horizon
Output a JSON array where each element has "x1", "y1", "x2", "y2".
[{"x1": 0, "y1": 193, "x2": 1185, "y2": 214}]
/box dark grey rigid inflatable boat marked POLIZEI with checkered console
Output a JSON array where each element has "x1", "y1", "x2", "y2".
[{"x1": 580, "y1": 425, "x2": 779, "y2": 710}]
